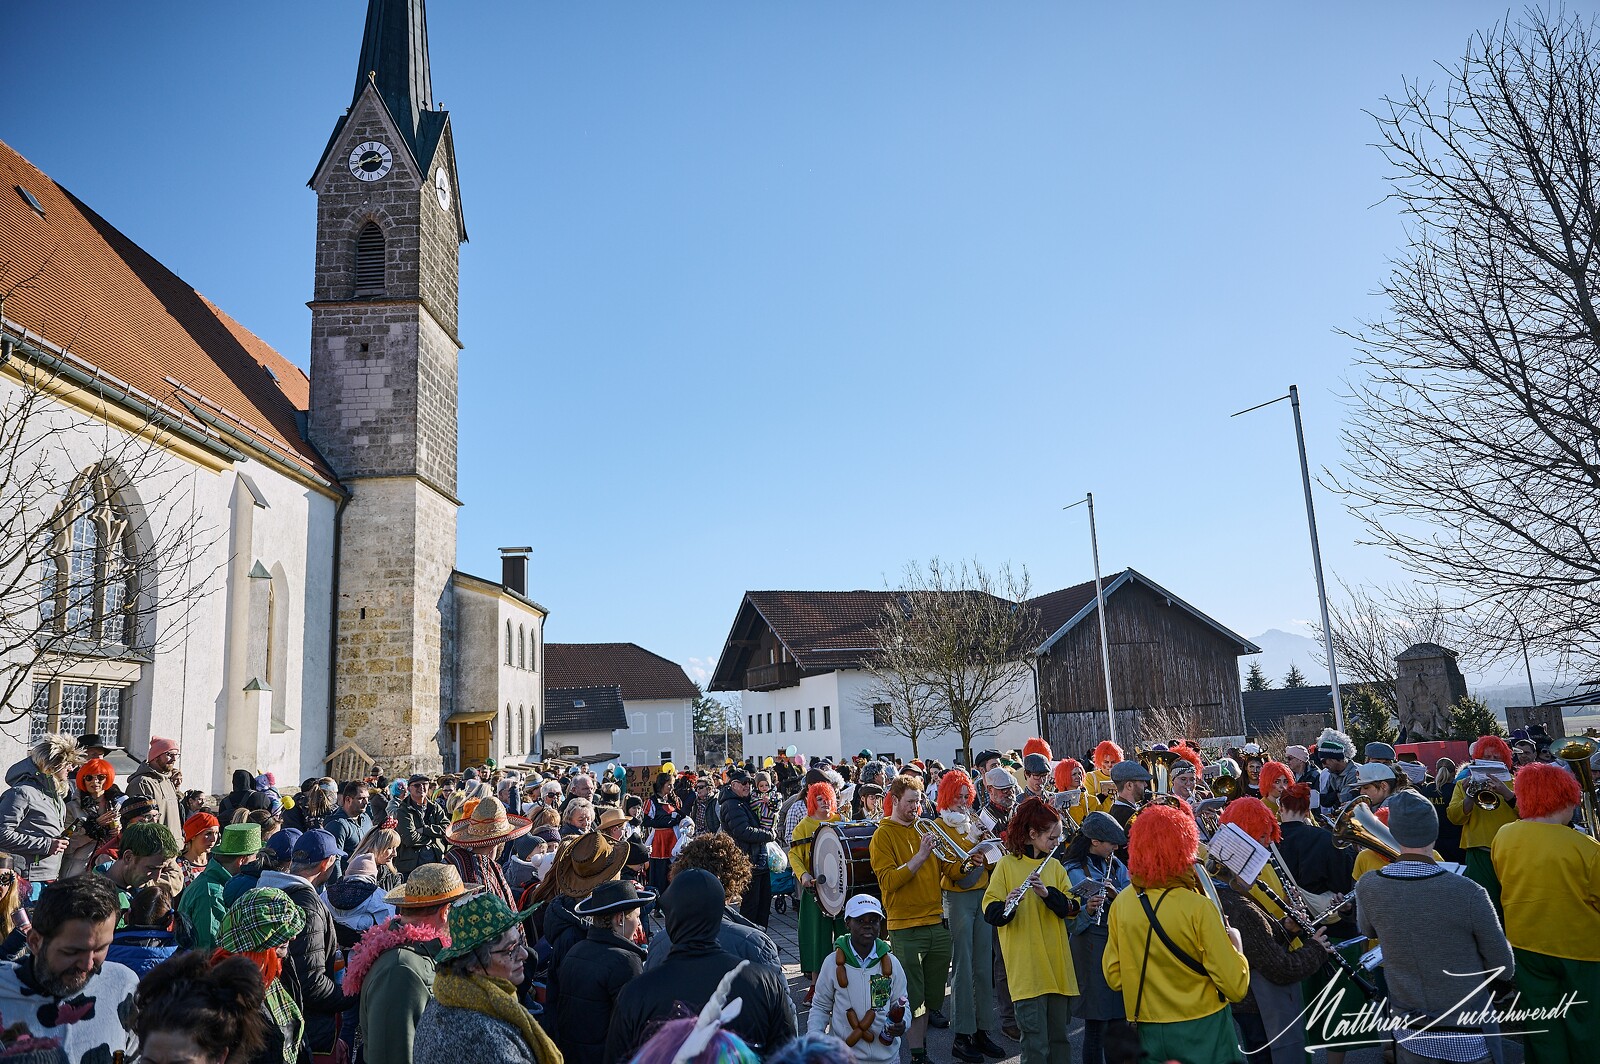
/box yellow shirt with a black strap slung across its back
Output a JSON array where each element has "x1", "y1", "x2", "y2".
[{"x1": 1100, "y1": 888, "x2": 1250, "y2": 1024}]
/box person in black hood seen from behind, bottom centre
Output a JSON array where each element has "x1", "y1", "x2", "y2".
[{"x1": 605, "y1": 869, "x2": 795, "y2": 1061}]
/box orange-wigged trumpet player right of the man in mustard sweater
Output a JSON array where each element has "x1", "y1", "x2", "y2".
[{"x1": 934, "y1": 768, "x2": 1010, "y2": 1064}]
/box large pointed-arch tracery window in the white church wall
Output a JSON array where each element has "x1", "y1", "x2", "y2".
[{"x1": 38, "y1": 469, "x2": 136, "y2": 650}]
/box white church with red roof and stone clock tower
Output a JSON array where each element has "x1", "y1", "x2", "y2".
[{"x1": 0, "y1": 0, "x2": 547, "y2": 780}]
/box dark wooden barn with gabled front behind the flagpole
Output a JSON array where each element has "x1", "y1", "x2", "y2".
[{"x1": 1029, "y1": 570, "x2": 1261, "y2": 757}]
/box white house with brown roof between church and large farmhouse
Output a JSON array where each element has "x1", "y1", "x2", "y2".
[{"x1": 544, "y1": 643, "x2": 699, "y2": 765}]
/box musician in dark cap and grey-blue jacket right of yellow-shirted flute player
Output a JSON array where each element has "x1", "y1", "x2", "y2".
[{"x1": 1062, "y1": 811, "x2": 1128, "y2": 1064}]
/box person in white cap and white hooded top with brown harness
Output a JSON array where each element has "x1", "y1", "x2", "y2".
[{"x1": 806, "y1": 894, "x2": 908, "y2": 1062}]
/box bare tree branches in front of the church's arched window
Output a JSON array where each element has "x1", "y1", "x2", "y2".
[{"x1": 0, "y1": 302, "x2": 221, "y2": 723}]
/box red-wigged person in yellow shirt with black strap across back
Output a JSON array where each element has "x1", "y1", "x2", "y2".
[{"x1": 1101, "y1": 805, "x2": 1250, "y2": 1064}]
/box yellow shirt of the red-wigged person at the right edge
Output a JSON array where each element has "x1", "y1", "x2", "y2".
[{"x1": 1490, "y1": 821, "x2": 1600, "y2": 960}]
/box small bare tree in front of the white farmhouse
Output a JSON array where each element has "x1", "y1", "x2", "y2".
[{"x1": 867, "y1": 558, "x2": 1038, "y2": 758}]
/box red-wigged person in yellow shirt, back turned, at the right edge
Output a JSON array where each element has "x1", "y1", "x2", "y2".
[{"x1": 1491, "y1": 763, "x2": 1600, "y2": 1064}]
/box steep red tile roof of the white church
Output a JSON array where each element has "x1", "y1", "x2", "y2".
[{"x1": 0, "y1": 141, "x2": 333, "y2": 480}]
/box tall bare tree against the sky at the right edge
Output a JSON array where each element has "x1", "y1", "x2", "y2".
[{"x1": 1336, "y1": 11, "x2": 1600, "y2": 664}]
